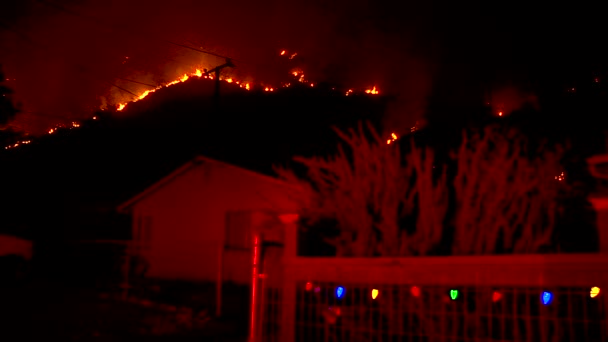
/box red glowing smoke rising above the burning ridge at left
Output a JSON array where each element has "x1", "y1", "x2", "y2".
[{"x1": 0, "y1": 0, "x2": 436, "y2": 135}]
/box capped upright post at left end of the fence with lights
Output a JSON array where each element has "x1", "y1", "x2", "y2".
[{"x1": 279, "y1": 214, "x2": 298, "y2": 342}]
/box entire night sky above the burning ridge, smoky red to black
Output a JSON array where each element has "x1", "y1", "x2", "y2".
[{"x1": 0, "y1": 0, "x2": 606, "y2": 132}]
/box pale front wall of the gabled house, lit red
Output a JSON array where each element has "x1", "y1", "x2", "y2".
[{"x1": 133, "y1": 162, "x2": 296, "y2": 283}]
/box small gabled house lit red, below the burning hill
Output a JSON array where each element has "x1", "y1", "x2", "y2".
[{"x1": 118, "y1": 156, "x2": 297, "y2": 285}]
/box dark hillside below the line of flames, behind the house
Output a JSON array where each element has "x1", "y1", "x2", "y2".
[{"x1": 0, "y1": 79, "x2": 387, "y2": 239}]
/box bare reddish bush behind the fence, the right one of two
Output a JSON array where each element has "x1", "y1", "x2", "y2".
[{"x1": 452, "y1": 126, "x2": 561, "y2": 254}]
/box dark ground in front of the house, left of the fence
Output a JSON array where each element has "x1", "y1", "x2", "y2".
[{"x1": 0, "y1": 280, "x2": 248, "y2": 342}]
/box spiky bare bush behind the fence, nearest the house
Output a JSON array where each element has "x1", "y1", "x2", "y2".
[{"x1": 277, "y1": 124, "x2": 447, "y2": 256}]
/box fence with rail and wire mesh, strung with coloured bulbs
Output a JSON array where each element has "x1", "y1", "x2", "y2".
[{"x1": 257, "y1": 222, "x2": 608, "y2": 342}]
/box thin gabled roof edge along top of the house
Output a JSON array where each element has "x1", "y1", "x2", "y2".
[{"x1": 117, "y1": 156, "x2": 295, "y2": 212}]
